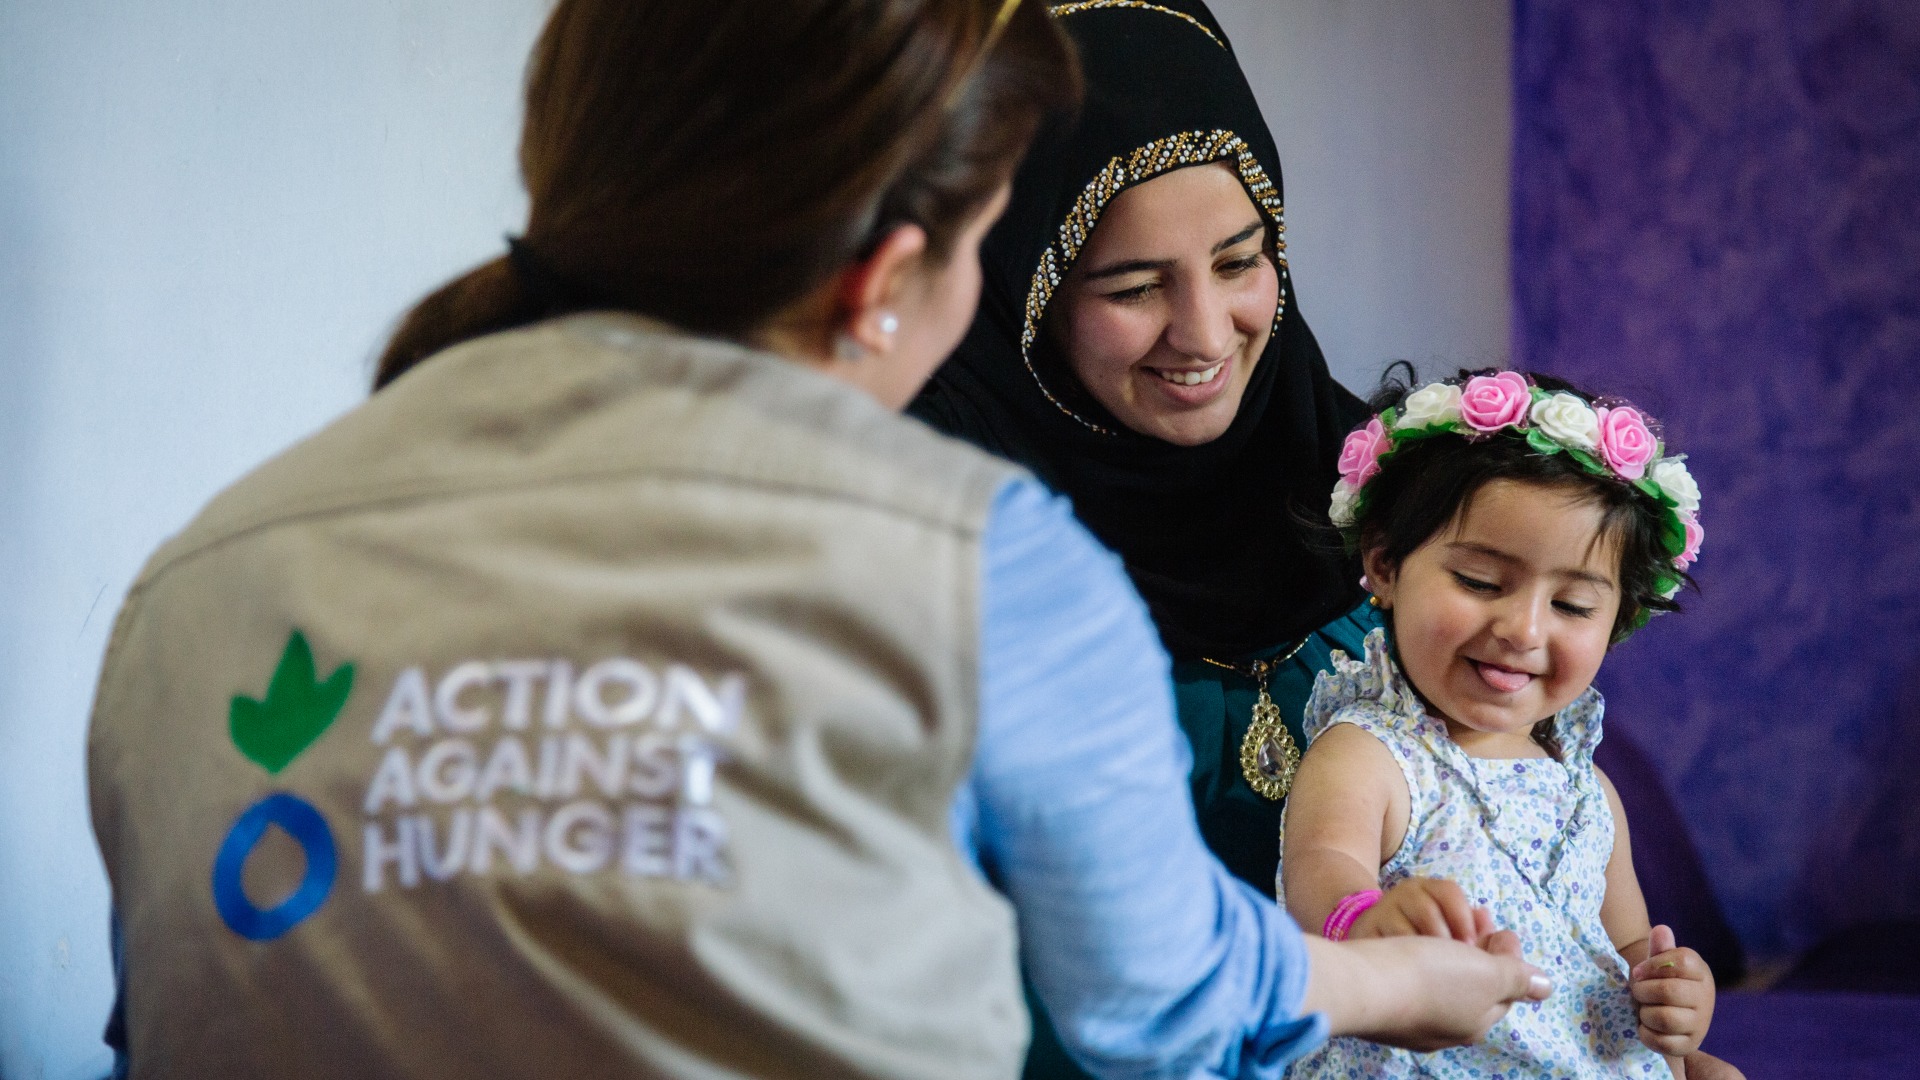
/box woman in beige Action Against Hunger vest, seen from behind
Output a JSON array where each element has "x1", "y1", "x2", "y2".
[{"x1": 90, "y1": 0, "x2": 1546, "y2": 1078}]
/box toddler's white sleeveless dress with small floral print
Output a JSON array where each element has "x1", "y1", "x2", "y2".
[{"x1": 1281, "y1": 630, "x2": 1668, "y2": 1080}]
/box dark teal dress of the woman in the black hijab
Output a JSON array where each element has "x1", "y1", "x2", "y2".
[{"x1": 1023, "y1": 603, "x2": 1382, "y2": 1080}]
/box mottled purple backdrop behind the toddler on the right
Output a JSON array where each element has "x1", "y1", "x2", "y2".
[{"x1": 1513, "y1": 0, "x2": 1920, "y2": 959}]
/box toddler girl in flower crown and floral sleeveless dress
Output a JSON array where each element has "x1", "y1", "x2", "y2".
[{"x1": 1281, "y1": 371, "x2": 1726, "y2": 1080}]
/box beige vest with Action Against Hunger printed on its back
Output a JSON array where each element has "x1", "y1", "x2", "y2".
[{"x1": 90, "y1": 315, "x2": 1027, "y2": 1080}]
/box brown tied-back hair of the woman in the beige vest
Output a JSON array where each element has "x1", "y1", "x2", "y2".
[{"x1": 374, "y1": 0, "x2": 1079, "y2": 390}]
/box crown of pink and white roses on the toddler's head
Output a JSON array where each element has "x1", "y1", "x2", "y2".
[{"x1": 1329, "y1": 371, "x2": 1707, "y2": 600}]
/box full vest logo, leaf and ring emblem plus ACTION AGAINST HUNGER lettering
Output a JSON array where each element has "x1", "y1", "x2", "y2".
[{"x1": 213, "y1": 630, "x2": 747, "y2": 942}]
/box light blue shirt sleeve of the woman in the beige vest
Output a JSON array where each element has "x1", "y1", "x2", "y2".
[{"x1": 954, "y1": 479, "x2": 1327, "y2": 1078}]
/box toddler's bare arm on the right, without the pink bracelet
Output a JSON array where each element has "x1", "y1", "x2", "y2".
[{"x1": 1596, "y1": 769, "x2": 1715, "y2": 1078}]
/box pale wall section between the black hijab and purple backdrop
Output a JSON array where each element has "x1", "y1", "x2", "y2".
[{"x1": 1212, "y1": 0, "x2": 1513, "y2": 394}]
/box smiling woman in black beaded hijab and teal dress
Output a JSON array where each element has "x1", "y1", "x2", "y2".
[{"x1": 912, "y1": 0, "x2": 1375, "y2": 1076}]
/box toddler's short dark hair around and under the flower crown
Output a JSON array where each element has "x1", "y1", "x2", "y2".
[{"x1": 1356, "y1": 371, "x2": 1692, "y2": 644}]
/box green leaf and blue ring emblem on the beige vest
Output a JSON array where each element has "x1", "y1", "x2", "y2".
[{"x1": 213, "y1": 630, "x2": 353, "y2": 942}]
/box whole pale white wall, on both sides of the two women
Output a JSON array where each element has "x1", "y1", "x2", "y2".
[{"x1": 0, "y1": 0, "x2": 1507, "y2": 1080}]
